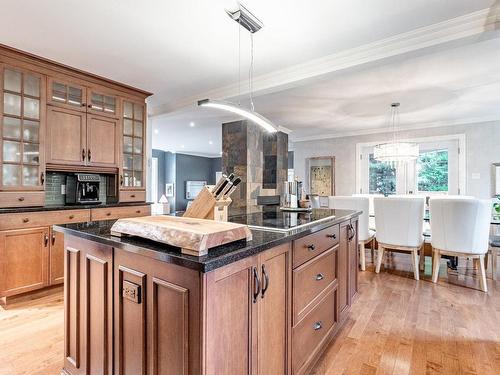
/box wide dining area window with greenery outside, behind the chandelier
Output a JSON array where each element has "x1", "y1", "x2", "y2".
[{"x1": 356, "y1": 134, "x2": 466, "y2": 196}]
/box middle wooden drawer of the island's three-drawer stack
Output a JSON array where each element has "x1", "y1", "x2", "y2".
[{"x1": 293, "y1": 249, "x2": 337, "y2": 323}]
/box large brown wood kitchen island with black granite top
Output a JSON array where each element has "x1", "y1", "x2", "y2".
[{"x1": 56, "y1": 209, "x2": 360, "y2": 375}]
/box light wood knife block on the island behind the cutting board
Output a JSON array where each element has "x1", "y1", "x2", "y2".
[{"x1": 182, "y1": 186, "x2": 232, "y2": 221}]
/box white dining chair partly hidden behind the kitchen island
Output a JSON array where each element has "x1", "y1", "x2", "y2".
[{"x1": 328, "y1": 196, "x2": 375, "y2": 271}]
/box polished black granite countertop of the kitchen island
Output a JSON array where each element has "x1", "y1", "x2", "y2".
[{"x1": 55, "y1": 210, "x2": 361, "y2": 272}]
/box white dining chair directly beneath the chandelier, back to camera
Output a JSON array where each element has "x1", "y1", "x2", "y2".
[{"x1": 373, "y1": 197, "x2": 425, "y2": 280}]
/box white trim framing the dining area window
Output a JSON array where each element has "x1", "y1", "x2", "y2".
[{"x1": 356, "y1": 134, "x2": 467, "y2": 195}]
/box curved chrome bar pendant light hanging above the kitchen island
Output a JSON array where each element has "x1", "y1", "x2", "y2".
[{"x1": 198, "y1": 3, "x2": 279, "y2": 133}]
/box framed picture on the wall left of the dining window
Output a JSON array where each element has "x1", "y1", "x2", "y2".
[{"x1": 306, "y1": 156, "x2": 335, "y2": 197}]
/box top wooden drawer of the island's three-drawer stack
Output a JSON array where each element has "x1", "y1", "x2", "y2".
[{"x1": 293, "y1": 224, "x2": 339, "y2": 268}]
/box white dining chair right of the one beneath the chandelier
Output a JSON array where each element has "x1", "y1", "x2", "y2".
[{"x1": 430, "y1": 198, "x2": 491, "y2": 292}]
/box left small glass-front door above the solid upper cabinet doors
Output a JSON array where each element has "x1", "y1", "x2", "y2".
[{"x1": 47, "y1": 78, "x2": 87, "y2": 112}]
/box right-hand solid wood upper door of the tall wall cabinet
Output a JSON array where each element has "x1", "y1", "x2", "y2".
[{"x1": 87, "y1": 115, "x2": 119, "y2": 167}]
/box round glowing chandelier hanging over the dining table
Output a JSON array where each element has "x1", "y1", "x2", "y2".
[{"x1": 373, "y1": 103, "x2": 419, "y2": 164}]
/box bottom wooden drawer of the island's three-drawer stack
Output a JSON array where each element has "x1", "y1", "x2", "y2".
[{"x1": 292, "y1": 288, "x2": 336, "y2": 374}]
